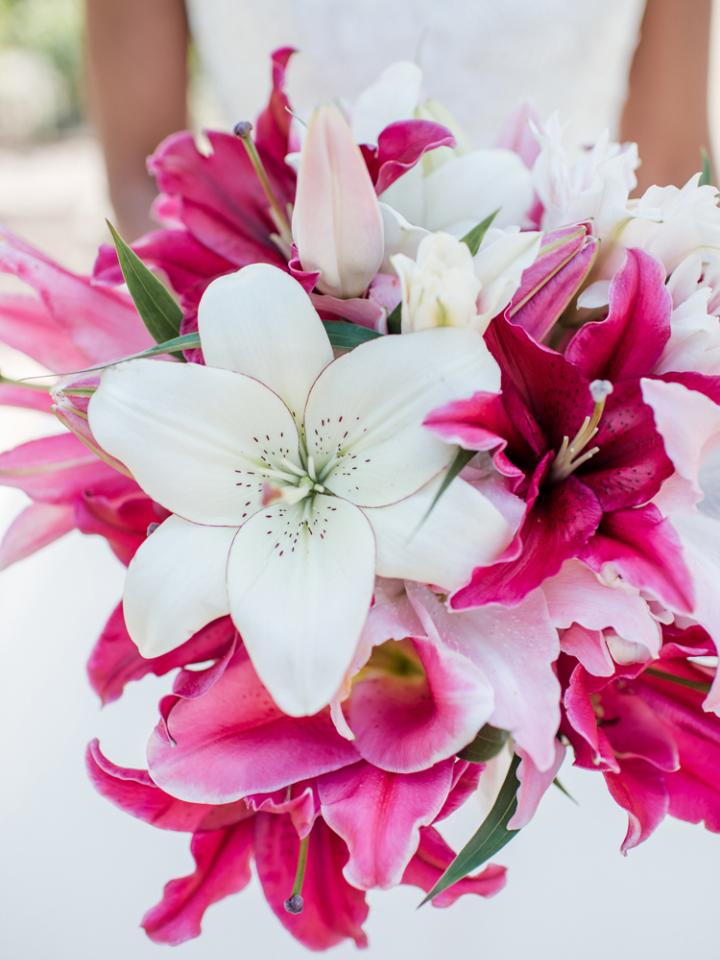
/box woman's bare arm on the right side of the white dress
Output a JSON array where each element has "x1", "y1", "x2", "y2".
[{"x1": 622, "y1": 0, "x2": 712, "y2": 189}]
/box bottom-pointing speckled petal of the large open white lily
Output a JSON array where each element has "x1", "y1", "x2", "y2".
[{"x1": 227, "y1": 496, "x2": 375, "y2": 716}]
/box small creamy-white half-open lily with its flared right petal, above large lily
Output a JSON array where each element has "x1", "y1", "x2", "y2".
[{"x1": 391, "y1": 229, "x2": 542, "y2": 333}]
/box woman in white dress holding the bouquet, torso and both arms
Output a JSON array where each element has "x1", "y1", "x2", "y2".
[{"x1": 86, "y1": 0, "x2": 712, "y2": 237}]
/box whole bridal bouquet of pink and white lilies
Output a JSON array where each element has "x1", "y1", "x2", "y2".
[{"x1": 0, "y1": 49, "x2": 720, "y2": 949}]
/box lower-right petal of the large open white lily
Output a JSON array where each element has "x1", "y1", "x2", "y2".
[{"x1": 365, "y1": 477, "x2": 513, "y2": 590}]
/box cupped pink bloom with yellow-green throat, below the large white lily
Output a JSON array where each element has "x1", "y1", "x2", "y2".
[{"x1": 346, "y1": 637, "x2": 494, "y2": 773}]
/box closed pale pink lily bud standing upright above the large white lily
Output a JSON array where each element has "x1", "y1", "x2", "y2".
[{"x1": 292, "y1": 105, "x2": 383, "y2": 299}]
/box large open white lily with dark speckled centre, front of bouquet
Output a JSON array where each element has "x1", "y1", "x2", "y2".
[{"x1": 89, "y1": 265, "x2": 511, "y2": 715}]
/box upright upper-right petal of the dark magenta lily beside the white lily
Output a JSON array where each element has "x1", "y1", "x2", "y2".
[{"x1": 565, "y1": 250, "x2": 672, "y2": 383}]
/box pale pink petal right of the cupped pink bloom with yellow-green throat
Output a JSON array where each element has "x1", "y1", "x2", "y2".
[{"x1": 408, "y1": 584, "x2": 560, "y2": 770}]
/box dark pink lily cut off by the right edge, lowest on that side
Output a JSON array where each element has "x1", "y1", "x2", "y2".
[{"x1": 561, "y1": 627, "x2": 720, "y2": 852}]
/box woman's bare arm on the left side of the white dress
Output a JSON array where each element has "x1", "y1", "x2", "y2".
[{"x1": 86, "y1": 0, "x2": 188, "y2": 239}]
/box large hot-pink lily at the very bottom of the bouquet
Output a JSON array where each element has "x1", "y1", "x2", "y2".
[{"x1": 88, "y1": 641, "x2": 505, "y2": 949}]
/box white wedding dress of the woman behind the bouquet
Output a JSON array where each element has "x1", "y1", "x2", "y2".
[{"x1": 187, "y1": 0, "x2": 645, "y2": 146}]
